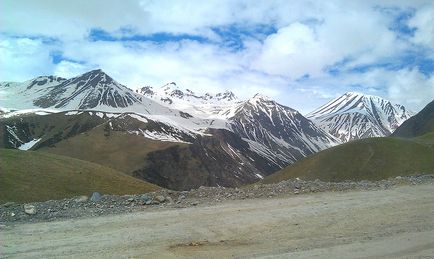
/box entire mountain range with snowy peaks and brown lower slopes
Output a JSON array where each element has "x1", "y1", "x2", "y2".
[{"x1": 0, "y1": 70, "x2": 413, "y2": 190}]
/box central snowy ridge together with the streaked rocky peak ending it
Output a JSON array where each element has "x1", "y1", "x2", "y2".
[{"x1": 138, "y1": 82, "x2": 340, "y2": 170}]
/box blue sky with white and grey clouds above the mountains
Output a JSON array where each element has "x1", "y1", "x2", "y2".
[{"x1": 0, "y1": 0, "x2": 434, "y2": 113}]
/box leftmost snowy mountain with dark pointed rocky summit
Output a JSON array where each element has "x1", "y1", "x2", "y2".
[{"x1": 0, "y1": 69, "x2": 175, "y2": 114}]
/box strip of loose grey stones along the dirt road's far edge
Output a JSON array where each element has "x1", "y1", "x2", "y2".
[{"x1": 0, "y1": 175, "x2": 434, "y2": 224}]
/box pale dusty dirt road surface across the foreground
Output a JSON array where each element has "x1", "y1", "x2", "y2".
[{"x1": 0, "y1": 184, "x2": 434, "y2": 258}]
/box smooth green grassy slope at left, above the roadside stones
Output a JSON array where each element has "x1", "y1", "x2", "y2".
[{"x1": 0, "y1": 149, "x2": 159, "y2": 203}]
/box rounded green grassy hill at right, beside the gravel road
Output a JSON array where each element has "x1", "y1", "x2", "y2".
[{"x1": 263, "y1": 134, "x2": 434, "y2": 183}]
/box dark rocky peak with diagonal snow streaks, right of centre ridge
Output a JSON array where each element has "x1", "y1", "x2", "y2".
[{"x1": 229, "y1": 94, "x2": 339, "y2": 170}]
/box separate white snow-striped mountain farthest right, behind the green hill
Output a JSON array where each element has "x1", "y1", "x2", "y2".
[{"x1": 306, "y1": 92, "x2": 414, "y2": 142}]
